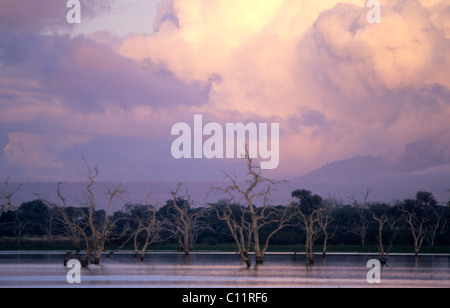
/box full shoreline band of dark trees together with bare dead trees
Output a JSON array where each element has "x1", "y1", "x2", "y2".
[{"x1": 0, "y1": 159, "x2": 450, "y2": 266}]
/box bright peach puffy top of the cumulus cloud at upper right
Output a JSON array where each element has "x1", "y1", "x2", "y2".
[{"x1": 313, "y1": 1, "x2": 450, "y2": 95}]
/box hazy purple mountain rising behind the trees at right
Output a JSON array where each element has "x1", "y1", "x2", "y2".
[{"x1": 291, "y1": 156, "x2": 450, "y2": 204}]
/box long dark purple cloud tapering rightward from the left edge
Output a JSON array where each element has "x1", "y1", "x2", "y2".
[{"x1": 0, "y1": 34, "x2": 208, "y2": 112}]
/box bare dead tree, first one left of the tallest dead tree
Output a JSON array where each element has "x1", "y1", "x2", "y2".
[{"x1": 164, "y1": 184, "x2": 209, "y2": 256}]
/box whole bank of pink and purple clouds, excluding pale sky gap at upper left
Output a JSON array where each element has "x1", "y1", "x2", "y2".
[{"x1": 0, "y1": 0, "x2": 450, "y2": 182}]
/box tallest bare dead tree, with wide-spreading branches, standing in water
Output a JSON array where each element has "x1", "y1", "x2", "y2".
[{"x1": 212, "y1": 152, "x2": 293, "y2": 267}]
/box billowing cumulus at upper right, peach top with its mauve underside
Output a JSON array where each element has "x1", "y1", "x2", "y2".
[{"x1": 288, "y1": 1, "x2": 450, "y2": 171}]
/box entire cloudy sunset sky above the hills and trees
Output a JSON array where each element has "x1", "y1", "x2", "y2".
[{"x1": 0, "y1": 0, "x2": 450, "y2": 182}]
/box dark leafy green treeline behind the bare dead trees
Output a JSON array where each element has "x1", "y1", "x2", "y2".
[{"x1": 0, "y1": 190, "x2": 450, "y2": 252}]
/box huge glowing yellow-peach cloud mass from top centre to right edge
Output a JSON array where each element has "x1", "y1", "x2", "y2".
[{"x1": 120, "y1": 0, "x2": 450, "y2": 178}]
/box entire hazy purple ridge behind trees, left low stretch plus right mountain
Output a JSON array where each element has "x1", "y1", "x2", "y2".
[{"x1": 7, "y1": 156, "x2": 450, "y2": 210}]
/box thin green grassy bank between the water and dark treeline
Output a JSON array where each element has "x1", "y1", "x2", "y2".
[{"x1": 0, "y1": 238, "x2": 450, "y2": 254}]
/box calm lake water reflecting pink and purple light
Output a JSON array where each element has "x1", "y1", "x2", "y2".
[{"x1": 0, "y1": 252, "x2": 450, "y2": 288}]
